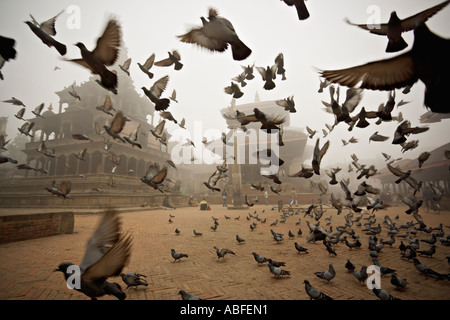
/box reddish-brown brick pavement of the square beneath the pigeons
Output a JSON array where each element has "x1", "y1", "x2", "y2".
[{"x1": 0, "y1": 205, "x2": 450, "y2": 300}]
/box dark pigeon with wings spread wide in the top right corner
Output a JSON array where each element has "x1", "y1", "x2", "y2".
[{"x1": 346, "y1": 1, "x2": 450, "y2": 52}]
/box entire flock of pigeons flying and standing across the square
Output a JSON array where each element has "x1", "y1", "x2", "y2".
[{"x1": 0, "y1": 0, "x2": 450, "y2": 299}]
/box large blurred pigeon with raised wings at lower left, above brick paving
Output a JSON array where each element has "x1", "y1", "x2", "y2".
[{"x1": 55, "y1": 210, "x2": 132, "y2": 300}]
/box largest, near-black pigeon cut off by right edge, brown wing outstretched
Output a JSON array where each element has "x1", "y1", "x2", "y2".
[{"x1": 320, "y1": 23, "x2": 450, "y2": 113}]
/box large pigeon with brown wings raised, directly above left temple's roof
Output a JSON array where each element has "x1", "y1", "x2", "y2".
[{"x1": 69, "y1": 19, "x2": 122, "y2": 93}]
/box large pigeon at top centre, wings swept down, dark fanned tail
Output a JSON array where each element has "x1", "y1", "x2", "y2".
[{"x1": 178, "y1": 8, "x2": 252, "y2": 61}]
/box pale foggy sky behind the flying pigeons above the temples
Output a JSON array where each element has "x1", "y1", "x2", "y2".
[{"x1": 0, "y1": 0, "x2": 450, "y2": 169}]
